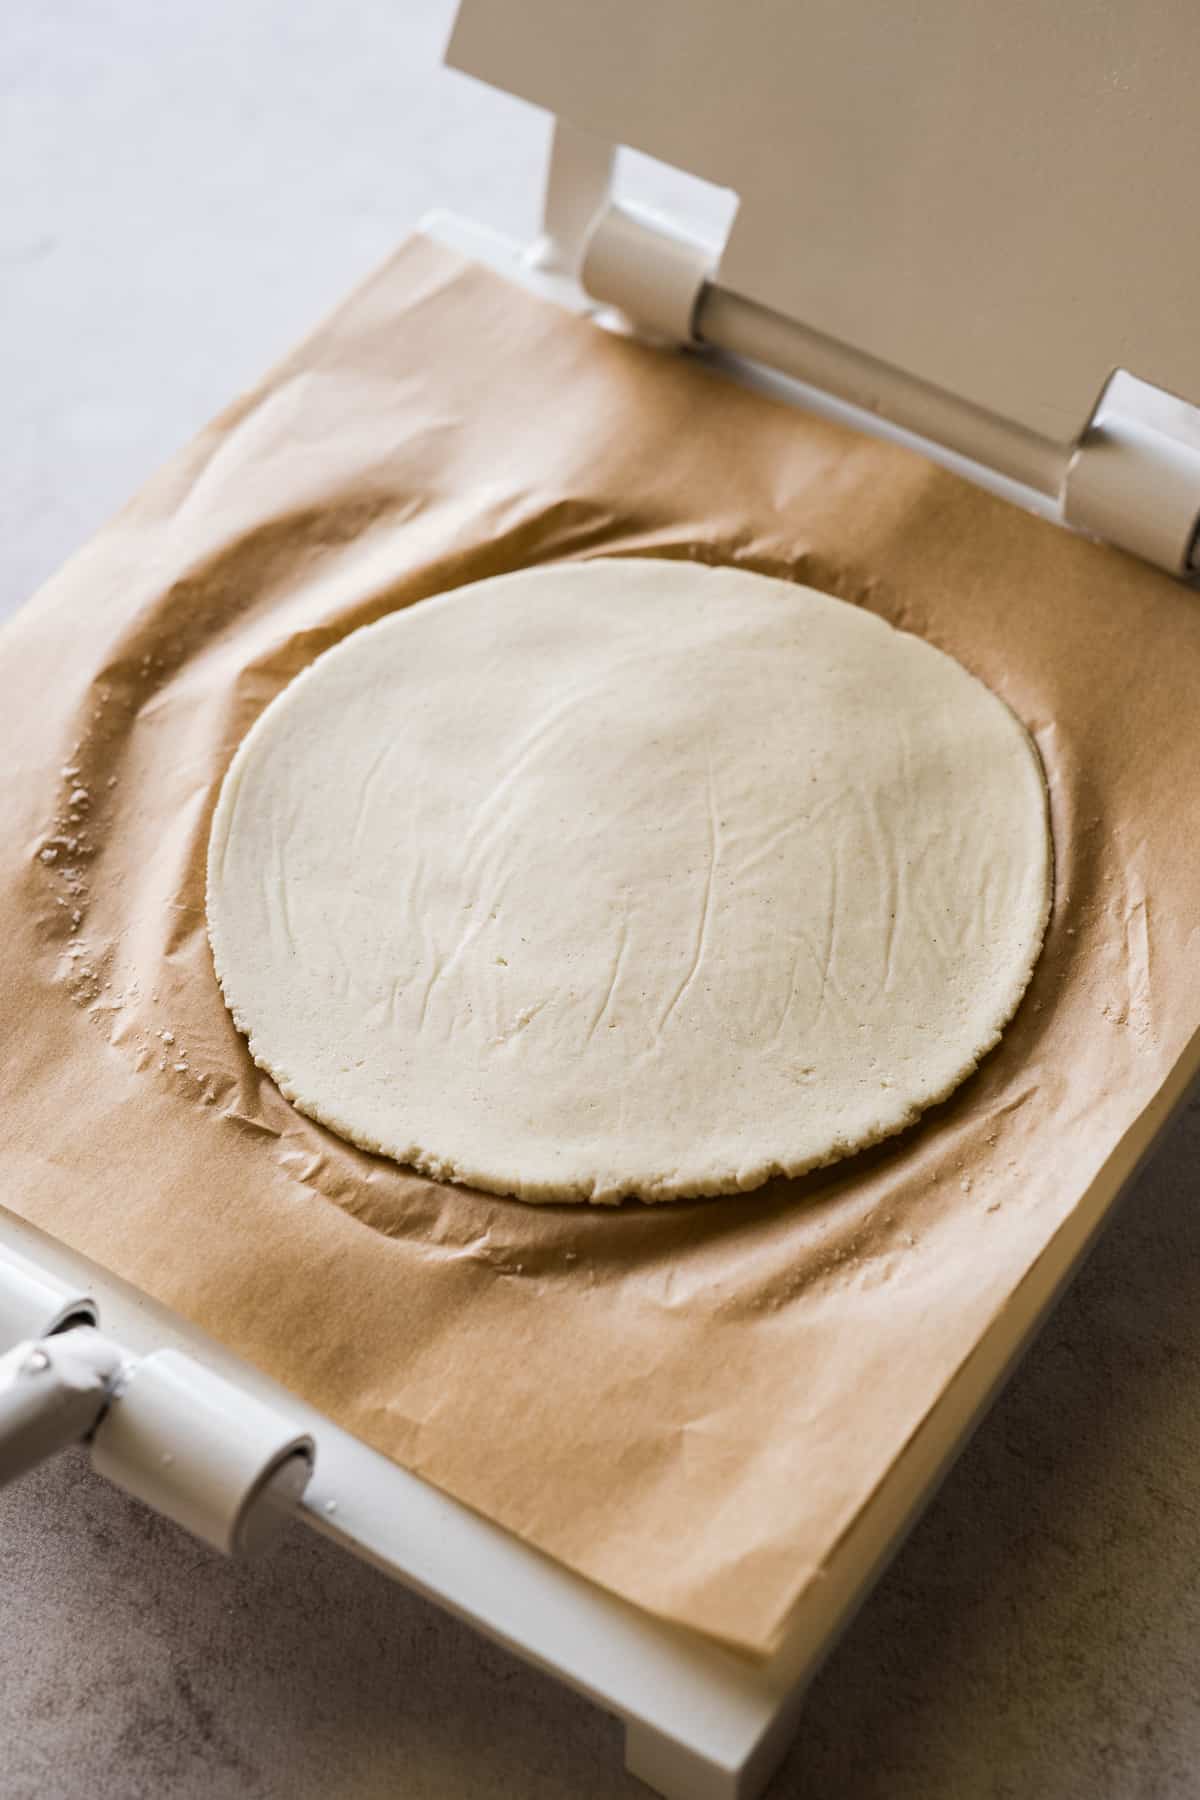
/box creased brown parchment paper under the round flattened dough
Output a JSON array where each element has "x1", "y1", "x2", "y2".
[{"x1": 0, "y1": 239, "x2": 1200, "y2": 1652}]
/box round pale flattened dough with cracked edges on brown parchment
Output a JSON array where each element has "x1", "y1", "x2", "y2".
[{"x1": 209, "y1": 560, "x2": 1051, "y2": 1201}]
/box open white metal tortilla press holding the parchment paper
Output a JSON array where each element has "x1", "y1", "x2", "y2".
[{"x1": 0, "y1": 0, "x2": 1200, "y2": 1800}]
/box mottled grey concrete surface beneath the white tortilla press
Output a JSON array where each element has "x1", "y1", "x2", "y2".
[{"x1": 0, "y1": 0, "x2": 1200, "y2": 1800}]
